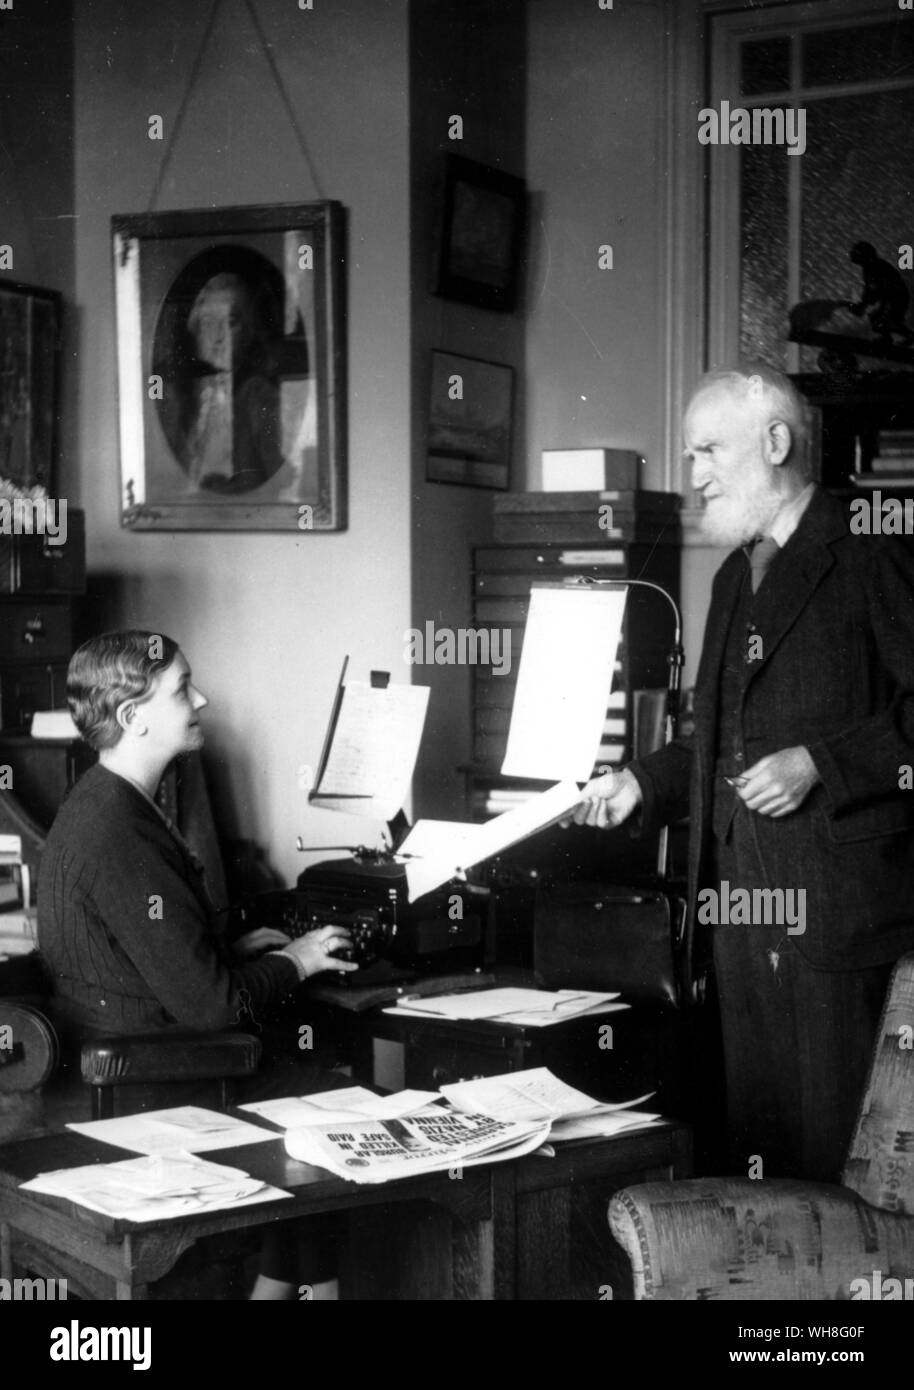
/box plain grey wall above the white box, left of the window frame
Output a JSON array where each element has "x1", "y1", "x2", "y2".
[{"x1": 526, "y1": 0, "x2": 667, "y2": 488}]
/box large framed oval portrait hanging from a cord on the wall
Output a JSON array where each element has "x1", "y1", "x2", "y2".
[{"x1": 111, "y1": 202, "x2": 346, "y2": 531}]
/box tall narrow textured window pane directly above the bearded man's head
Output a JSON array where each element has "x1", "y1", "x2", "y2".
[{"x1": 739, "y1": 145, "x2": 790, "y2": 370}]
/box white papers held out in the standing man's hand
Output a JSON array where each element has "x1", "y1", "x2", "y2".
[{"x1": 400, "y1": 781, "x2": 581, "y2": 902}]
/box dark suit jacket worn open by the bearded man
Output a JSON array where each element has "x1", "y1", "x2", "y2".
[{"x1": 631, "y1": 489, "x2": 914, "y2": 969}]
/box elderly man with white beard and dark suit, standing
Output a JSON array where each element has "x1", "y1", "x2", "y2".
[{"x1": 575, "y1": 366, "x2": 914, "y2": 1182}]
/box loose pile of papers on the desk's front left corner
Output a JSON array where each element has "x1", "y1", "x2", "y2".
[{"x1": 21, "y1": 1156, "x2": 290, "y2": 1222}]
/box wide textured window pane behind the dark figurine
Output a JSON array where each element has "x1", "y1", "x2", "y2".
[{"x1": 800, "y1": 89, "x2": 914, "y2": 370}]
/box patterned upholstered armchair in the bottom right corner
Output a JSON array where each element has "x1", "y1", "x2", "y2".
[{"x1": 610, "y1": 954, "x2": 914, "y2": 1300}]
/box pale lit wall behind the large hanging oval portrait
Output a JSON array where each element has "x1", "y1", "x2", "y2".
[{"x1": 74, "y1": 0, "x2": 410, "y2": 881}]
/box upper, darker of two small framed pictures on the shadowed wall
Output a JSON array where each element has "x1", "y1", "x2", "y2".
[{"x1": 435, "y1": 154, "x2": 526, "y2": 311}]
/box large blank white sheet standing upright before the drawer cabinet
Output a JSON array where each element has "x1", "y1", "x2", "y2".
[{"x1": 501, "y1": 585, "x2": 626, "y2": 781}]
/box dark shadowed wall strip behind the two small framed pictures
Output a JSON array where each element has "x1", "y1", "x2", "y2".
[{"x1": 410, "y1": 0, "x2": 525, "y2": 820}]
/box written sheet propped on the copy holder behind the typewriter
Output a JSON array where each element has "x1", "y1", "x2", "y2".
[{"x1": 308, "y1": 681, "x2": 429, "y2": 820}]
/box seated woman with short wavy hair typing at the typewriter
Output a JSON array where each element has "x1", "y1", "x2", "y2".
[{"x1": 38, "y1": 631, "x2": 357, "y2": 1298}]
